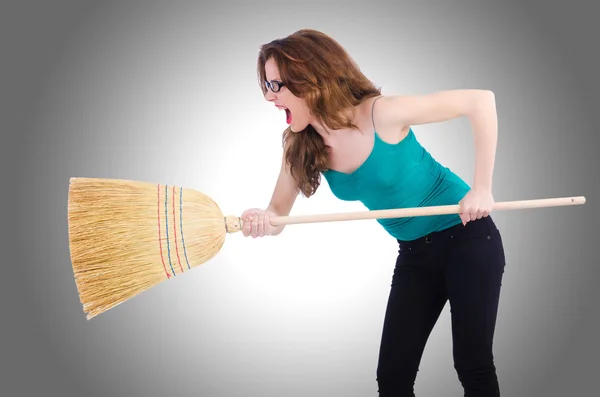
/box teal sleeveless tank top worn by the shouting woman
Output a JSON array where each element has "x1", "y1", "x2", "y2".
[{"x1": 323, "y1": 97, "x2": 470, "y2": 241}]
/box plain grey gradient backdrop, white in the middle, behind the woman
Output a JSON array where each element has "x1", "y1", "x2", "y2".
[{"x1": 0, "y1": 0, "x2": 600, "y2": 397}]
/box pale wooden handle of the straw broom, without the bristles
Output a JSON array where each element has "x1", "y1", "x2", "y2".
[{"x1": 269, "y1": 196, "x2": 585, "y2": 226}]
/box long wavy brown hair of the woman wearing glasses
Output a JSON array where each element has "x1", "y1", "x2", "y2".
[{"x1": 257, "y1": 29, "x2": 381, "y2": 197}]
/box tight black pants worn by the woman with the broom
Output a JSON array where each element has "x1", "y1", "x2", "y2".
[{"x1": 377, "y1": 216, "x2": 505, "y2": 397}]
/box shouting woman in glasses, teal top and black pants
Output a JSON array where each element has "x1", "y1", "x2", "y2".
[{"x1": 242, "y1": 29, "x2": 505, "y2": 397}]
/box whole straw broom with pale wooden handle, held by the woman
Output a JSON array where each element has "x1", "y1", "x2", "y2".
[{"x1": 67, "y1": 178, "x2": 585, "y2": 320}]
